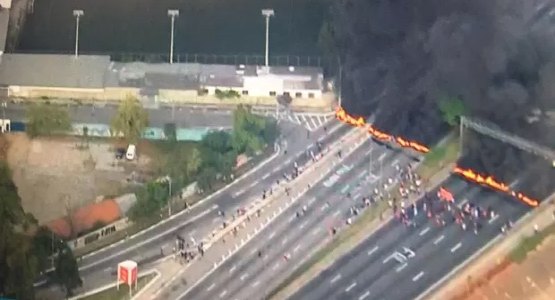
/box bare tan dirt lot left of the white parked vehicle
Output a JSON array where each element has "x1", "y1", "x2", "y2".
[{"x1": 4, "y1": 134, "x2": 153, "y2": 223}]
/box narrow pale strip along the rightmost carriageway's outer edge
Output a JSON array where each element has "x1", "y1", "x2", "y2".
[{"x1": 426, "y1": 195, "x2": 555, "y2": 300}]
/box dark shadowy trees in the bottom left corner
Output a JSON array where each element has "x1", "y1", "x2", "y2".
[{"x1": 0, "y1": 161, "x2": 82, "y2": 300}]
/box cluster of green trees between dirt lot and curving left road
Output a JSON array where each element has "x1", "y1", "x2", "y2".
[{"x1": 130, "y1": 105, "x2": 279, "y2": 220}]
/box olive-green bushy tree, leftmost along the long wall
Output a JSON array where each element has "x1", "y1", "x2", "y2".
[{"x1": 27, "y1": 104, "x2": 71, "y2": 137}]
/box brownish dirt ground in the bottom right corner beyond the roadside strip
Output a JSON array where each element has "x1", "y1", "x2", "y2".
[{"x1": 457, "y1": 237, "x2": 555, "y2": 300}]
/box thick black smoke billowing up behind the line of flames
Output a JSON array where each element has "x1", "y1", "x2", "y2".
[{"x1": 332, "y1": 0, "x2": 555, "y2": 197}]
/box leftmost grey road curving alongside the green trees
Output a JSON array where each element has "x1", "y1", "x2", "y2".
[{"x1": 38, "y1": 121, "x2": 351, "y2": 289}]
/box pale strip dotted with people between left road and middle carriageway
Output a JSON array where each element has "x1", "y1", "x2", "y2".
[{"x1": 136, "y1": 129, "x2": 366, "y2": 299}]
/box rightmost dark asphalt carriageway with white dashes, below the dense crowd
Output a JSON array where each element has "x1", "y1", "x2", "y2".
[{"x1": 292, "y1": 176, "x2": 530, "y2": 300}]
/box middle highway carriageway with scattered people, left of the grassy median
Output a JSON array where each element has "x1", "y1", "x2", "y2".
[{"x1": 180, "y1": 140, "x2": 411, "y2": 300}]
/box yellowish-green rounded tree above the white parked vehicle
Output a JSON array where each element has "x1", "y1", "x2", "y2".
[{"x1": 110, "y1": 95, "x2": 148, "y2": 144}]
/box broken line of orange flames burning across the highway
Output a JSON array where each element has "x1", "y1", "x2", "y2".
[{"x1": 335, "y1": 107, "x2": 539, "y2": 207}]
